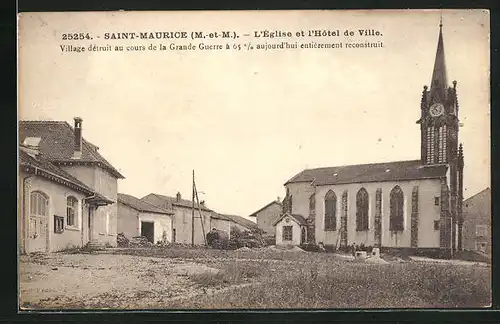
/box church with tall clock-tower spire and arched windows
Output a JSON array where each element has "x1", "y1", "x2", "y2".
[{"x1": 274, "y1": 23, "x2": 464, "y2": 256}]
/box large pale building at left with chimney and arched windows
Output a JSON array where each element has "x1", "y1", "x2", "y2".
[{"x1": 18, "y1": 117, "x2": 124, "y2": 253}]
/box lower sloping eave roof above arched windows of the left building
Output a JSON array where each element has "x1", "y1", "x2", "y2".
[{"x1": 19, "y1": 149, "x2": 114, "y2": 204}]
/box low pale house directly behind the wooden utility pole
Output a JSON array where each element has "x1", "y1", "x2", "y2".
[{"x1": 141, "y1": 192, "x2": 230, "y2": 245}]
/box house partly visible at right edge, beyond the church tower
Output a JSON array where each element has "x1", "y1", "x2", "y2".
[{"x1": 463, "y1": 188, "x2": 491, "y2": 256}]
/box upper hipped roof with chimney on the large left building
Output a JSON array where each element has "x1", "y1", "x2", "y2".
[{"x1": 19, "y1": 120, "x2": 124, "y2": 179}]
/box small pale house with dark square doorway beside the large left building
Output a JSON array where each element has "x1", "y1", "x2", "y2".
[{"x1": 118, "y1": 193, "x2": 174, "y2": 243}]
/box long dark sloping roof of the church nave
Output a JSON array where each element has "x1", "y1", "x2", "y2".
[{"x1": 285, "y1": 160, "x2": 448, "y2": 186}]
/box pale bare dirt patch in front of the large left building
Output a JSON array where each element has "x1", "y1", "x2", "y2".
[{"x1": 19, "y1": 254, "x2": 226, "y2": 309}]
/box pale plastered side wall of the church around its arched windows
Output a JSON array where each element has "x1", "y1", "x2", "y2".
[{"x1": 290, "y1": 179, "x2": 441, "y2": 248}]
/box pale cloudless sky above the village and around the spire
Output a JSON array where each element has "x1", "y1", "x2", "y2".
[{"x1": 18, "y1": 10, "x2": 490, "y2": 216}]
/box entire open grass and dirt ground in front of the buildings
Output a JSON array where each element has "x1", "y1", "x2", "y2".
[{"x1": 20, "y1": 248, "x2": 491, "y2": 309}]
